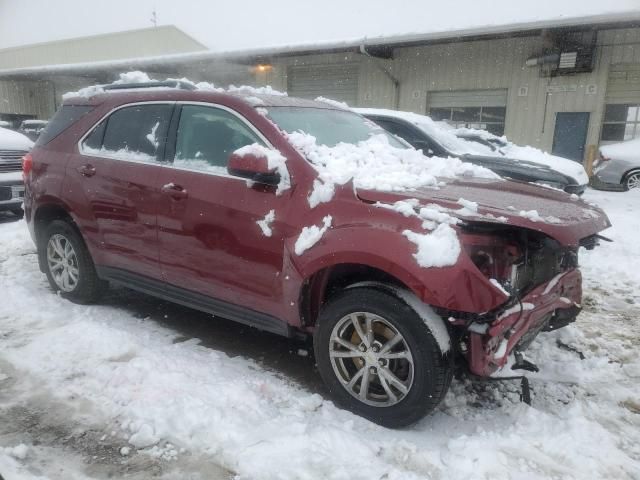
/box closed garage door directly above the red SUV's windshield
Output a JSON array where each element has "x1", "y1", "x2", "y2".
[{"x1": 287, "y1": 64, "x2": 359, "y2": 105}]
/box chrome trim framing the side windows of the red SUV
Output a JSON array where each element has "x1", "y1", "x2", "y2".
[{"x1": 76, "y1": 100, "x2": 284, "y2": 182}]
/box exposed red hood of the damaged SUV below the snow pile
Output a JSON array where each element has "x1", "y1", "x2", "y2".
[{"x1": 357, "y1": 179, "x2": 611, "y2": 246}]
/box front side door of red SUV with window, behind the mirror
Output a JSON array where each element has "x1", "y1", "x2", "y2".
[{"x1": 158, "y1": 105, "x2": 292, "y2": 322}]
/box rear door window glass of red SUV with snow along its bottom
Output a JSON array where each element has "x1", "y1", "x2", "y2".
[{"x1": 83, "y1": 104, "x2": 173, "y2": 162}]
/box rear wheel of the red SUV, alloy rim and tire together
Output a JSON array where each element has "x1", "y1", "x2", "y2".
[{"x1": 39, "y1": 220, "x2": 107, "y2": 303}]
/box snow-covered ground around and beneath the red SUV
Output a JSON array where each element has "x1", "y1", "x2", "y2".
[{"x1": 0, "y1": 190, "x2": 640, "y2": 480}]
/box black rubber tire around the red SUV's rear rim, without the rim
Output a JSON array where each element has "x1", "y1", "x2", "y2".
[{"x1": 38, "y1": 220, "x2": 108, "y2": 304}]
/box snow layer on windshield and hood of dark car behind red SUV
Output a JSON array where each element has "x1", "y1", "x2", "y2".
[{"x1": 355, "y1": 108, "x2": 589, "y2": 185}]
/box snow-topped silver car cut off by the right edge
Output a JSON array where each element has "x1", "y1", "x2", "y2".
[{"x1": 592, "y1": 138, "x2": 640, "y2": 190}]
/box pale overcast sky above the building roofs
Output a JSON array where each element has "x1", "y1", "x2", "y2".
[{"x1": 0, "y1": 0, "x2": 640, "y2": 51}]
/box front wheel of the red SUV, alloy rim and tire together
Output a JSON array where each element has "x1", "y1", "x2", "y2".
[{"x1": 314, "y1": 287, "x2": 452, "y2": 428}]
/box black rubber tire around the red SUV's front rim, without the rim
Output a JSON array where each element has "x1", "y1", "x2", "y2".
[{"x1": 314, "y1": 286, "x2": 453, "y2": 428}]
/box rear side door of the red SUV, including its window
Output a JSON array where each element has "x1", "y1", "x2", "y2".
[{"x1": 65, "y1": 103, "x2": 174, "y2": 280}]
